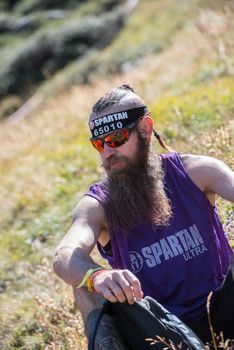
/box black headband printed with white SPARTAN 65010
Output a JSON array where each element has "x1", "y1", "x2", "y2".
[{"x1": 89, "y1": 106, "x2": 148, "y2": 138}]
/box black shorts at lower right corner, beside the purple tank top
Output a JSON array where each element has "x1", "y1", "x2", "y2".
[{"x1": 185, "y1": 265, "x2": 234, "y2": 342}]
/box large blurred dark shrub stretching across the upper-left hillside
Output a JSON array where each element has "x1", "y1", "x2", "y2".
[{"x1": 0, "y1": 9, "x2": 123, "y2": 96}]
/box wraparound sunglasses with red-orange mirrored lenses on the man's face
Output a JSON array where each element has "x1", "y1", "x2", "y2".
[{"x1": 90, "y1": 122, "x2": 137, "y2": 152}]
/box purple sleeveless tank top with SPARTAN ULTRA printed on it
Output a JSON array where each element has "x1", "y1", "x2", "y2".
[{"x1": 87, "y1": 152, "x2": 233, "y2": 321}]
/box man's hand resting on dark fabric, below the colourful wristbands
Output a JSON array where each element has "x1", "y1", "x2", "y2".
[{"x1": 93, "y1": 270, "x2": 143, "y2": 304}]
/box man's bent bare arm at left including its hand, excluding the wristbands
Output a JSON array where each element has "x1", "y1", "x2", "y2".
[{"x1": 53, "y1": 196, "x2": 143, "y2": 304}]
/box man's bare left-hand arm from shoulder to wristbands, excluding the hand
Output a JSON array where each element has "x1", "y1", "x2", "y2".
[{"x1": 53, "y1": 196, "x2": 105, "y2": 286}]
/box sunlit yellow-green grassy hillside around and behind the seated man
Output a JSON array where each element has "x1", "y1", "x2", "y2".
[{"x1": 0, "y1": 0, "x2": 234, "y2": 350}]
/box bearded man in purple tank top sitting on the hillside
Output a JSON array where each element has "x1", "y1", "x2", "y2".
[{"x1": 54, "y1": 85, "x2": 234, "y2": 350}]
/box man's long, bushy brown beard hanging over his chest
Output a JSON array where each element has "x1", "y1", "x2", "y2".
[{"x1": 104, "y1": 134, "x2": 171, "y2": 234}]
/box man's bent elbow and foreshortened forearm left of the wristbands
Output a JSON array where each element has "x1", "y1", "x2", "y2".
[{"x1": 53, "y1": 247, "x2": 101, "y2": 286}]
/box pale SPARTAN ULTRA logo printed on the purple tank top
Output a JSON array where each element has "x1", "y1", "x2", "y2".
[{"x1": 130, "y1": 225, "x2": 208, "y2": 272}]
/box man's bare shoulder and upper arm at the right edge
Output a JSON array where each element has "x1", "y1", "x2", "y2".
[{"x1": 182, "y1": 155, "x2": 234, "y2": 202}]
